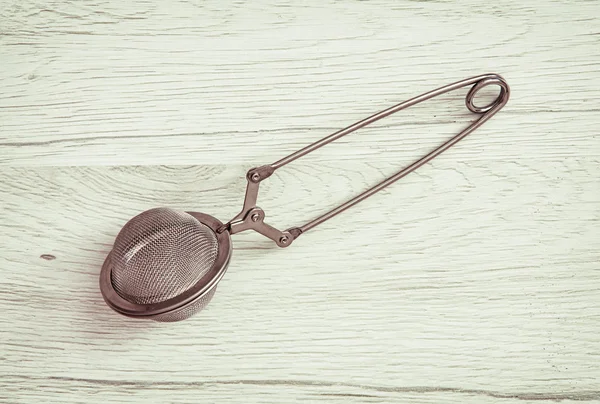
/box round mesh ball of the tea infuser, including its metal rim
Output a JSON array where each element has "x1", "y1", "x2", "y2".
[{"x1": 101, "y1": 208, "x2": 231, "y2": 321}]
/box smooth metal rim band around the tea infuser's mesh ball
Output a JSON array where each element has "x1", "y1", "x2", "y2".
[{"x1": 100, "y1": 212, "x2": 232, "y2": 317}]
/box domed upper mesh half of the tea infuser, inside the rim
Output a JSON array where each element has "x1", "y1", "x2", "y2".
[{"x1": 111, "y1": 208, "x2": 218, "y2": 304}]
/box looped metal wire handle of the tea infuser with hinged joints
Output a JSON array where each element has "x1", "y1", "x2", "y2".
[{"x1": 223, "y1": 74, "x2": 510, "y2": 247}]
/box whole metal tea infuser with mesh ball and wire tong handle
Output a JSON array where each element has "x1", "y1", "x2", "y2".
[{"x1": 100, "y1": 74, "x2": 510, "y2": 321}]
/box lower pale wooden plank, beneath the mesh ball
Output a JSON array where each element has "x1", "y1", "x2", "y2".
[{"x1": 0, "y1": 158, "x2": 600, "y2": 402}]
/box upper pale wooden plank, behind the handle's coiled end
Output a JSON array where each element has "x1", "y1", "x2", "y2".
[{"x1": 0, "y1": 0, "x2": 600, "y2": 165}]
